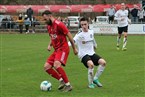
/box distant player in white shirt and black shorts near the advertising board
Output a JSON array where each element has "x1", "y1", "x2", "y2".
[{"x1": 114, "y1": 3, "x2": 130, "y2": 51}]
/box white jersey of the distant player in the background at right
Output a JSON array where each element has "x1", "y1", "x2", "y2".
[{"x1": 114, "y1": 10, "x2": 128, "y2": 27}]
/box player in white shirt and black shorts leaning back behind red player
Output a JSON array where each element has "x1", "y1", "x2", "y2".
[{"x1": 69, "y1": 17, "x2": 106, "y2": 88}]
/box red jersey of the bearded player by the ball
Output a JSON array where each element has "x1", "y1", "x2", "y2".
[{"x1": 47, "y1": 20, "x2": 69, "y2": 50}]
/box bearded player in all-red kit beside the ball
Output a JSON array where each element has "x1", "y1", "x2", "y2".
[{"x1": 42, "y1": 10, "x2": 77, "y2": 92}]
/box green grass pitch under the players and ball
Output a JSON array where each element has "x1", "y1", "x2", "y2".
[{"x1": 0, "y1": 34, "x2": 145, "y2": 97}]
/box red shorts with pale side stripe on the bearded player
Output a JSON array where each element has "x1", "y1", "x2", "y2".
[{"x1": 47, "y1": 49, "x2": 69, "y2": 66}]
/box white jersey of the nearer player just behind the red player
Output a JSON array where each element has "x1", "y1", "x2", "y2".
[{"x1": 73, "y1": 30, "x2": 97, "y2": 59}]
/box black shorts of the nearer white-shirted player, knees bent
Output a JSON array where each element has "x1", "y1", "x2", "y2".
[{"x1": 82, "y1": 54, "x2": 101, "y2": 68}]
